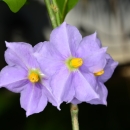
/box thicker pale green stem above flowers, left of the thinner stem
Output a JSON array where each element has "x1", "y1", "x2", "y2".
[{"x1": 44, "y1": 0, "x2": 58, "y2": 28}]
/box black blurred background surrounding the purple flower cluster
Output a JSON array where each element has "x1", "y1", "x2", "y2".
[{"x1": 0, "y1": 0, "x2": 130, "y2": 130}]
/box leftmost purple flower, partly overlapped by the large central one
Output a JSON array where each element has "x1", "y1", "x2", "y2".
[{"x1": 0, "y1": 42, "x2": 57, "y2": 116}]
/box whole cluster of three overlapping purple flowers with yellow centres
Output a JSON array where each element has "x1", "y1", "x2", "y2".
[{"x1": 0, "y1": 22, "x2": 118, "y2": 116}]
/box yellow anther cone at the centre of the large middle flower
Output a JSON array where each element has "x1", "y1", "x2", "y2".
[{"x1": 70, "y1": 58, "x2": 83, "y2": 68}]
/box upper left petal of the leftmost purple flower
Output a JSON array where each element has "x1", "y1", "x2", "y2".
[{"x1": 5, "y1": 42, "x2": 38, "y2": 69}]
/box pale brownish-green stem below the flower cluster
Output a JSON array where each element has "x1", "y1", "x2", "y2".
[{"x1": 70, "y1": 104, "x2": 79, "y2": 130}]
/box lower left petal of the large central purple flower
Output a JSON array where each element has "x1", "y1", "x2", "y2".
[{"x1": 50, "y1": 67, "x2": 70, "y2": 104}]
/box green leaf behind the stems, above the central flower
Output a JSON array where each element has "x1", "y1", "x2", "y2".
[{"x1": 56, "y1": 0, "x2": 79, "y2": 22}]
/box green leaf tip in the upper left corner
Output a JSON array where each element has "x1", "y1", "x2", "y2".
[{"x1": 3, "y1": 0, "x2": 26, "y2": 13}]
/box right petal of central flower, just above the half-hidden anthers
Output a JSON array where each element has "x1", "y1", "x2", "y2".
[{"x1": 84, "y1": 48, "x2": 106, "y2": 73}]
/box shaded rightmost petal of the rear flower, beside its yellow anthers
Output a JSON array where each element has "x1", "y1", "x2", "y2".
[{"x1": 98, "y1": 54, "x2": 118, "y2": 82}]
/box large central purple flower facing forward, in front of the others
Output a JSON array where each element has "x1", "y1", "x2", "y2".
[{"x1": 34, "y1": 22, "x2": 117, "y2": 104}]
